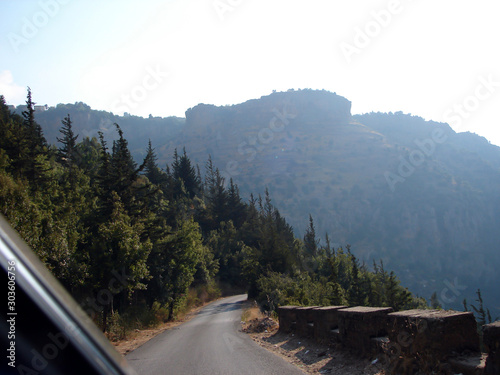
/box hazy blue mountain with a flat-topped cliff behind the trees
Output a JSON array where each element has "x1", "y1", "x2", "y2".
[{"x1": 30, "y1": 90, "x2": 500, "y2": 316}]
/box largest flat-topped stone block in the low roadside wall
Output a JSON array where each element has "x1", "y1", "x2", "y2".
[{"x1": 388, "y1": 310, "x2": 479, "y2": 368}]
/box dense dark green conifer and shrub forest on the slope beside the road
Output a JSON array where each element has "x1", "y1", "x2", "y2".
[{"x1": 0, "y1": 90, "x2": 426, "y2": 338}]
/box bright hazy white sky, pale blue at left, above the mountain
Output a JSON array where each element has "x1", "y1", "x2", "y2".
[{"x1": 0, "y1": 0, "x2": 500, "y2": 145}]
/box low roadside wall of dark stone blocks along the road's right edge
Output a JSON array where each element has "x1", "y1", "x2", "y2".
[{"x1": 278, "y1": 306, "x2": 500, "y2": 375}]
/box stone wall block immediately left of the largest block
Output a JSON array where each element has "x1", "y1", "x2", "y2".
[{"x1": 338, "y1": 306, "x2": 393, "y2": 354}]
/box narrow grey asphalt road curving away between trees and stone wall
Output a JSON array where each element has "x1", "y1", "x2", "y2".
[{"x1": 126, "y1": 295, "x2": 304, "y2": 375}]
